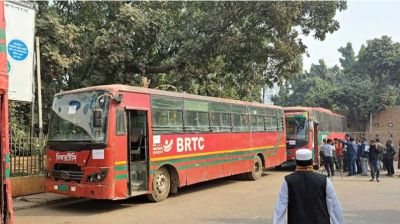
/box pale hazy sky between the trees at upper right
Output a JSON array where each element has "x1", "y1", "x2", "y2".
[{"x1": 303, "y1": 1, "x2": 400, "y2": 70}]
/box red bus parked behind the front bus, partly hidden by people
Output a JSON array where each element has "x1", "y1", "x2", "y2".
[{"x1": 285, "y1": 107, "x2": 347, "y2": 168}]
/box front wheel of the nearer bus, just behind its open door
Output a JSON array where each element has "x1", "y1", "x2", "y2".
[{"x1": 147, "y1": 167, "x2": 171, "y2": 202}]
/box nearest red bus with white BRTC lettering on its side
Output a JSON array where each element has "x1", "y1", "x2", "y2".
[{"x1": 45, "y1": 85, "x2": 286, "y2": 201}]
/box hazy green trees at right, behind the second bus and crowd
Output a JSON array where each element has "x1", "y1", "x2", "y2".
[{"x1": 273, "y1": 36, "x2": 400, "y2": 128}]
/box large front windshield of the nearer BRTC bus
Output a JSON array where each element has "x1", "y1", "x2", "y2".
[{"x1": 49, "y1": 91, "x2": 109, "y2": 143}]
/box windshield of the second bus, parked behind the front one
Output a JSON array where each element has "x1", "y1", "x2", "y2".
[{"x1": 286, "y1": 114, "x2": 308, "y2": 140}]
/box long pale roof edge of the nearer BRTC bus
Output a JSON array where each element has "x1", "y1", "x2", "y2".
[{"x1": 55, "y1": 84, "x2": 283, "y2": 110}]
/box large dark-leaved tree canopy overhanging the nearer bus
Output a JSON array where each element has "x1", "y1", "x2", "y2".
[{"x1": 30, "y1": 1, "x2": 346, "y2": 131}]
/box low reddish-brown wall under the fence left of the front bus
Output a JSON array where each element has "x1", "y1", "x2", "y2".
[{"x1": 11, "y1": 176, "x2": 44, "y2": 197}]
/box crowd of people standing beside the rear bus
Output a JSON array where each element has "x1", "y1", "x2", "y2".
[{"x1": 320, "y1": 134, "x2": 400, "y2": 182}]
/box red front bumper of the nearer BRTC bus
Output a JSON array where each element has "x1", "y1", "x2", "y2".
[{"x1": 44, "y1": 178, "x2": 116, "y2": 200}]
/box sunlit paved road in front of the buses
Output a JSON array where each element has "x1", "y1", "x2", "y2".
[{"x1": 16, "y1": 170, "x2": 400, "y2": 224}]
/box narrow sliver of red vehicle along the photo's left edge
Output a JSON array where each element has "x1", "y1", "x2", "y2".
[{"x1": 0, "y1": 1, "x2": 14, "y2": 224}]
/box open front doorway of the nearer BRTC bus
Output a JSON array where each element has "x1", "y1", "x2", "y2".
[{"x1": 127, "y1": 110, "x2": 149, "y2": 196}]
